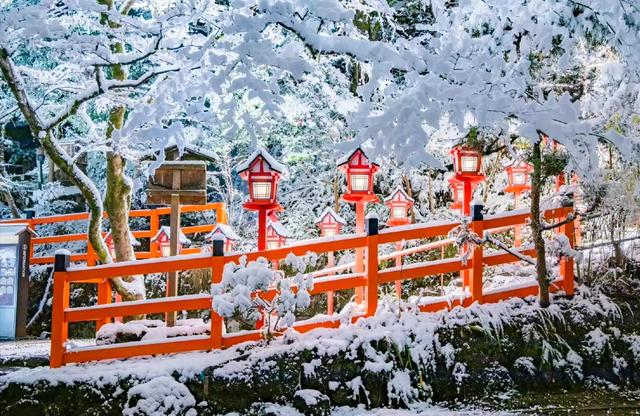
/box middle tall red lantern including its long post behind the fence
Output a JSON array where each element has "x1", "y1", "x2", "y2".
[{"x1": 337, "y1": 147, "x2": 380, "y2": 303}]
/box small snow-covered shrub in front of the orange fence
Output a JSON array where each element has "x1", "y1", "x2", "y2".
[{"x1": 211, "y1": 256, "x2": 313, "y2": 333}]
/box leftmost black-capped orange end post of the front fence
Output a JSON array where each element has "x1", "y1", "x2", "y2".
[{"x1": 49, "y1": 254, "x2": 71, "y2": 368}]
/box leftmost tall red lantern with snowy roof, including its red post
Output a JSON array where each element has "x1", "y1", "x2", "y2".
[{"x1": 236, "y1": 147, "x2": 287, "y2": 251}]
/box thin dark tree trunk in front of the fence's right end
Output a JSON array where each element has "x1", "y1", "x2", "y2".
[{"x1": 531, "y1": 139, "x2": 550, "y2": 308}]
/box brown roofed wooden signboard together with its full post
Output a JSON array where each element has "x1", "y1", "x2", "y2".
[{"x1": 147, "y1": 161, "x2": 207, "y2": 326}]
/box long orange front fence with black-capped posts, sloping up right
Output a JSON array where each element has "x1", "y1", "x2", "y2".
[{"x1": 50, "y1": 207, "x2": 574, "y2": 367}]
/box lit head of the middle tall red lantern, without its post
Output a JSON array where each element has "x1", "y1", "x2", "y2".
[{"x1": 338, "y1": 147, "x2": 380, "y2": 202}]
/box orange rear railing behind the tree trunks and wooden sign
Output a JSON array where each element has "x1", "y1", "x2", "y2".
[{"x1": 0, "y1": 202, "x2": 227, "y2": 266}]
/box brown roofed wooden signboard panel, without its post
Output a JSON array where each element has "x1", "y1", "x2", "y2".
[{"x1": 147, "y1": 160, "x2": 207, "y2": 205}]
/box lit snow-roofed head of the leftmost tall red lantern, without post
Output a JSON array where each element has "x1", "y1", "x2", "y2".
[{"x1": 236, "y1": 147, "x2": 287, "y2": 208}]
